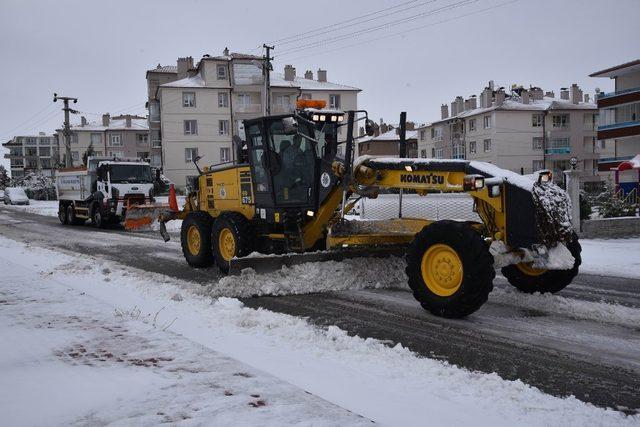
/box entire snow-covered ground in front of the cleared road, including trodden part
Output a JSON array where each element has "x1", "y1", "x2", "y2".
[{"x1": 0, "y1": 238, "x2": 640, "y2": 426}]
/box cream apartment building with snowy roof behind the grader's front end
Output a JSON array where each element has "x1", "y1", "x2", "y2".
[{"x1": 417, "y1": 82, "x2": 610, "y2": 188}]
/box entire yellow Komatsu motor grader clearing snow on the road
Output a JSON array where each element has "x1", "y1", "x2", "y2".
[{"x1": 126, "y1": 100, "x2": 580, "y2": 317}]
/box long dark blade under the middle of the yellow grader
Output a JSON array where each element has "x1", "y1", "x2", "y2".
[{"x1": 229, "y1": 246, "x2": 406, "y2": 275}]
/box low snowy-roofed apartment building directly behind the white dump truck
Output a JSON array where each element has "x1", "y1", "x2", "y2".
[{"x1": 57, "y1": 113, "x2": 150, "y2": 167}]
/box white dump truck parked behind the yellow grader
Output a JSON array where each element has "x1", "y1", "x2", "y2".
[{"x1": 56, "y1": 157, "x2": 153, "y2": 228}]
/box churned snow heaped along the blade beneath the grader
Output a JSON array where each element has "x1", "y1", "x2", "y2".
[{"x1": 209, "y1": 257, "x2": 407, "y2": 297}]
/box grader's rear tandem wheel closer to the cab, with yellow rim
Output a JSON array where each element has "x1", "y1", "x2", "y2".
[{"x1": 211, "y1": 213, "x2": 252, "y2": 274}]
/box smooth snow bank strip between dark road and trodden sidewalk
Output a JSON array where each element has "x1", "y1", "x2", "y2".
[{"x1": 0, "y1": 238, "x2": 640, "y2": 426}]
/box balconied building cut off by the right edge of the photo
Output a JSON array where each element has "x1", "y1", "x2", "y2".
[{"x1": 590, "y1": 59, "x2": 640, "y2": 192}]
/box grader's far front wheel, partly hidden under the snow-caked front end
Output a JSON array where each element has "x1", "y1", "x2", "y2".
[{"x1": 502, "y1": 233, "x2": 582, "y2": 294}]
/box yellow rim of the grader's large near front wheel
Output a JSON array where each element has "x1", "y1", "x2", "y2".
[{"x1": 420, "y1": 243, "x2": 463, "y2": 297}]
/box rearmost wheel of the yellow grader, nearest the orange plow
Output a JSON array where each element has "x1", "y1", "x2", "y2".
[{"x1": 180, "y1": 212, "x2": 213, "y2": 268}]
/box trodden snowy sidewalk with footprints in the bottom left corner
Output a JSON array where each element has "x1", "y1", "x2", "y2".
[{"x1": 0, "y1": 240, "x2": 370, "y2": 426}]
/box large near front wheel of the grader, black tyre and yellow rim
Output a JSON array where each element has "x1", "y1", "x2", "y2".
[{"x1": 406, "y1": 221, "x2": 496, "y2": 318}]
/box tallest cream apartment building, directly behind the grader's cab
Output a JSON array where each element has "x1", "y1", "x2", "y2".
[{"x1": 147, "y1": 49, "x2": 360, "y2": 187}]
